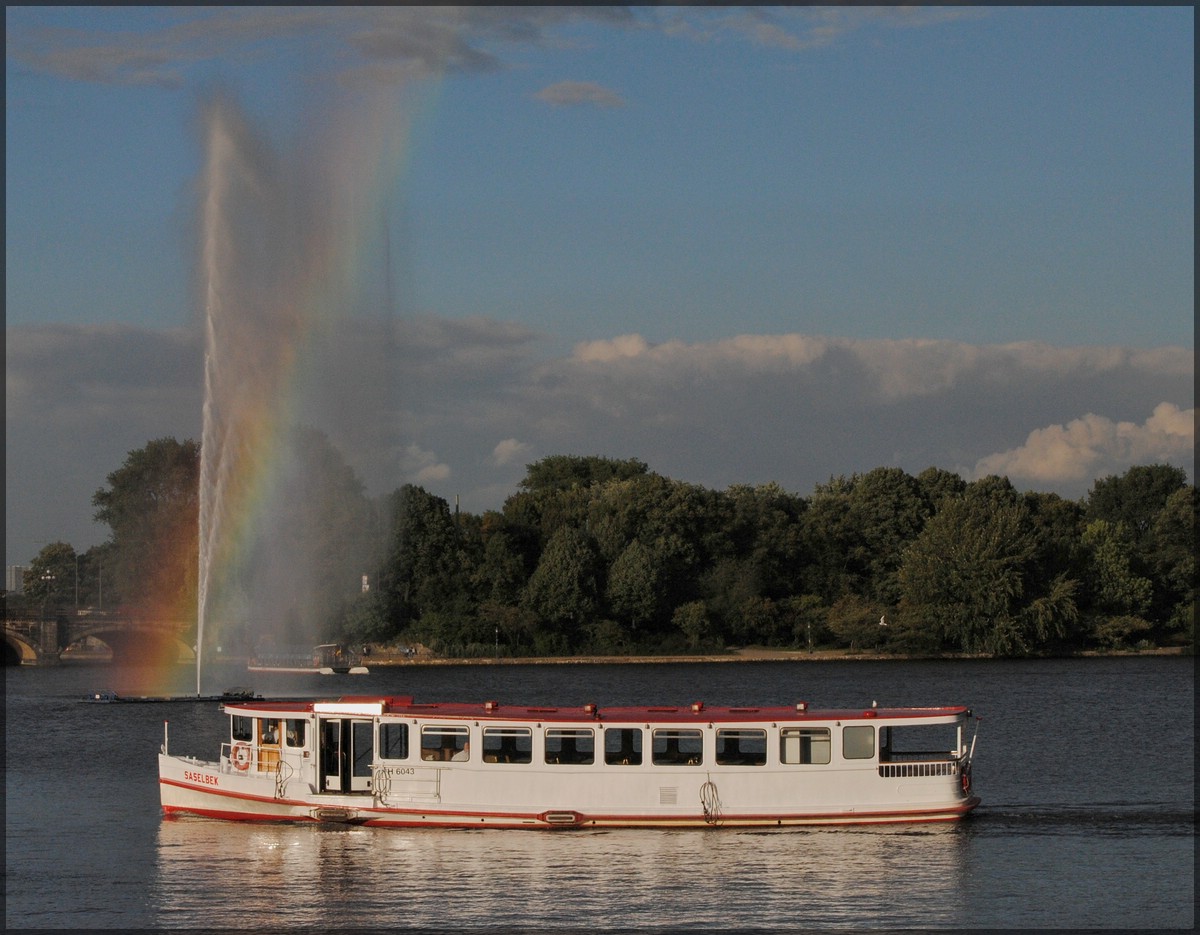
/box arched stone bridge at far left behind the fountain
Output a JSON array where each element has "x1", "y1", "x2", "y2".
[{"x1": 4, "y1": 613, "x2": 196, "y2": 665}]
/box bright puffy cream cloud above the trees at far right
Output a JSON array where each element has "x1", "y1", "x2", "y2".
[{"x1": 971, "y1": 402, "x2": 1195, "y2": 486}]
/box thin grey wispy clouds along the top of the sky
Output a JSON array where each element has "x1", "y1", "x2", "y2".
[{"x1": 8, "y1": 5, "x2": 980, "y2": 89}]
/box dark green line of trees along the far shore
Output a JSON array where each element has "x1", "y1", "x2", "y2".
[{"x1": 10, "y1": 433, "x2": 1196, "y2": 657}]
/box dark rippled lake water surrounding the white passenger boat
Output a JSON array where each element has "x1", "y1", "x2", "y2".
[{"x1": 5, "y1": 657, "x2": 1195, "y2": 931}]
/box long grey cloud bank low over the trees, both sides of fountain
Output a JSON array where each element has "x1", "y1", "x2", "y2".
[{"x1": 6, "y1": 317, "x2": 1195, "y2": 562}]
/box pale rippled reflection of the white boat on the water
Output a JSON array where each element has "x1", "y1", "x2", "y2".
[{"x1": 154, "y1": 816, "x2": 978, "y2": 934}]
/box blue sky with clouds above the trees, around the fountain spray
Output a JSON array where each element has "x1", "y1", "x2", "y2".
[{"x1": 6, "y1": 7, "x2": 1194, "y2": 562}]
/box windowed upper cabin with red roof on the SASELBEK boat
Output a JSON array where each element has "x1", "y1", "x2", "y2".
[{"x1": 222, "y1": 697, "x2": 970, "y2": 795}]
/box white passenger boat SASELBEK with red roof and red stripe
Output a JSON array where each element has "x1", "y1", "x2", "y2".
[{"x1": 158, "y1": 696, "x2": 979, "y2": 828}]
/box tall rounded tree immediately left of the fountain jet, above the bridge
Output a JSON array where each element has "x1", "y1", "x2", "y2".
[{"x1": 91, "y1": 438, "x2": 199, "y2": 613}]
